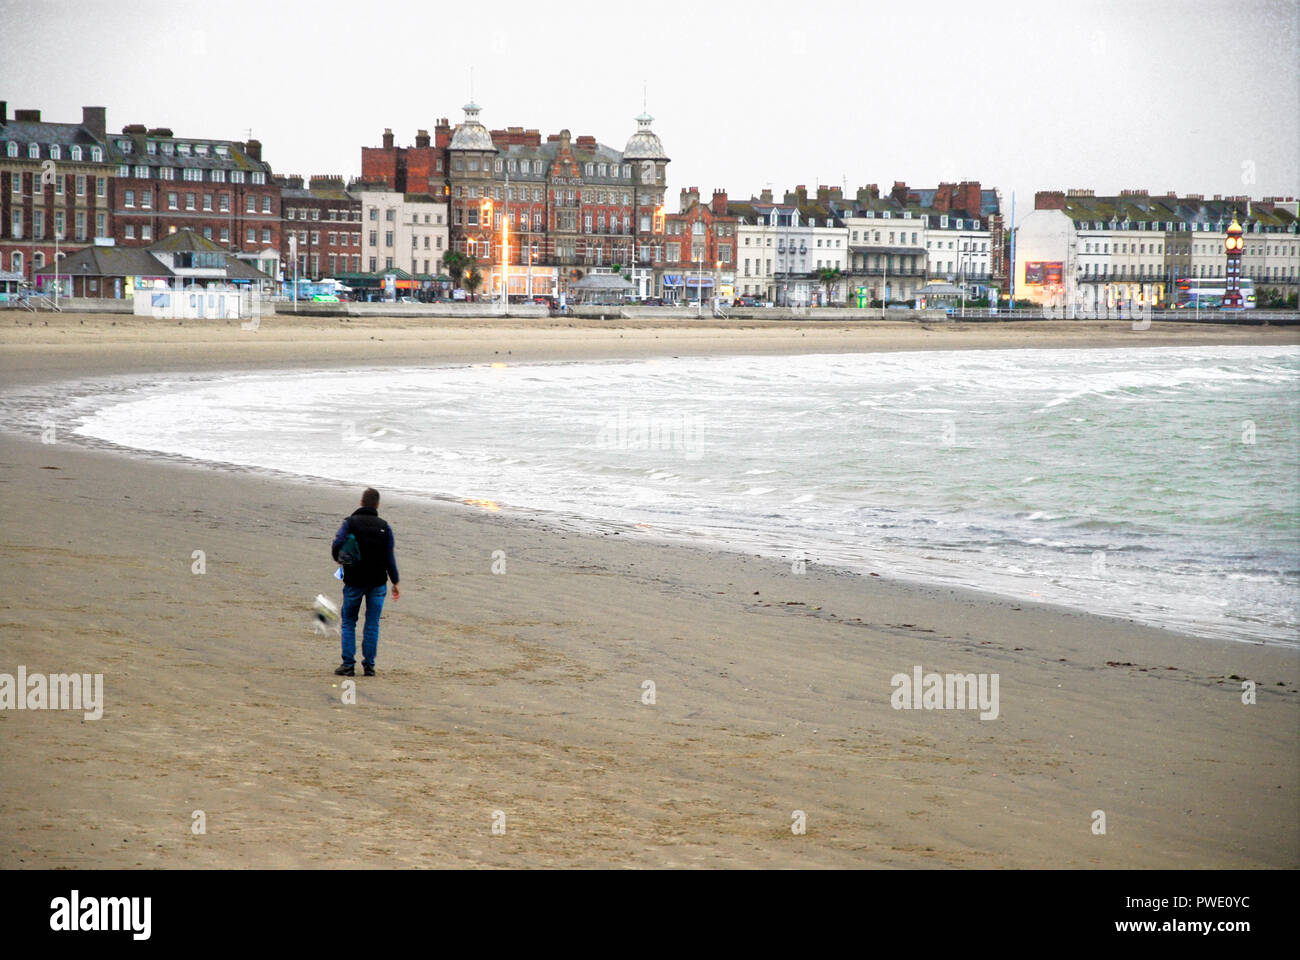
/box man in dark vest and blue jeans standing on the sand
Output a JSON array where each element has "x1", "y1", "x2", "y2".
[{"x1": 330, "y1": 487, "x2": 402, "y2": 676}]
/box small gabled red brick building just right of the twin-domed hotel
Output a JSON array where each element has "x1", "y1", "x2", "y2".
[{"x1": 655, "y1": 187, "x2": 740, "y2": 303}]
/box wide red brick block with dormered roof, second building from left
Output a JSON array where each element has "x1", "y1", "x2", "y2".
[{"x1": 107, "y1": 124, "x2": 281, "y2": 276}]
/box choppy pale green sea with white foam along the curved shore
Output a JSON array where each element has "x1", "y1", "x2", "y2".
[{"x1": 12, "y1": 346, "x2": 1300, "y2": 643}]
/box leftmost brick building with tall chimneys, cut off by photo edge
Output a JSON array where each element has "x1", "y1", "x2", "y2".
[{"x1": 0, "y1": 100, "x2": 116, "y2": 284}]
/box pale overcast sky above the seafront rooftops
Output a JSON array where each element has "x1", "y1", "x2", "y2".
[{"x1": 0, "y1": 0, "x2": 1300, "y2": 216}]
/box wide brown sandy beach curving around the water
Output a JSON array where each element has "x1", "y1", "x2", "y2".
[{"x1": 0, "y1": 313, "x2": 1300, "y2": 869}]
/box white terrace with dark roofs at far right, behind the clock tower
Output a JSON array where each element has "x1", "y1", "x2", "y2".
[{"x1": 1015, "y1": 189, "x2": 1300, "y2": 308}]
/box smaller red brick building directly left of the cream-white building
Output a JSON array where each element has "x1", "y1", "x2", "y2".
[{"x1": 276, "y1": 174, "x2": 361, "y2": 280}]
